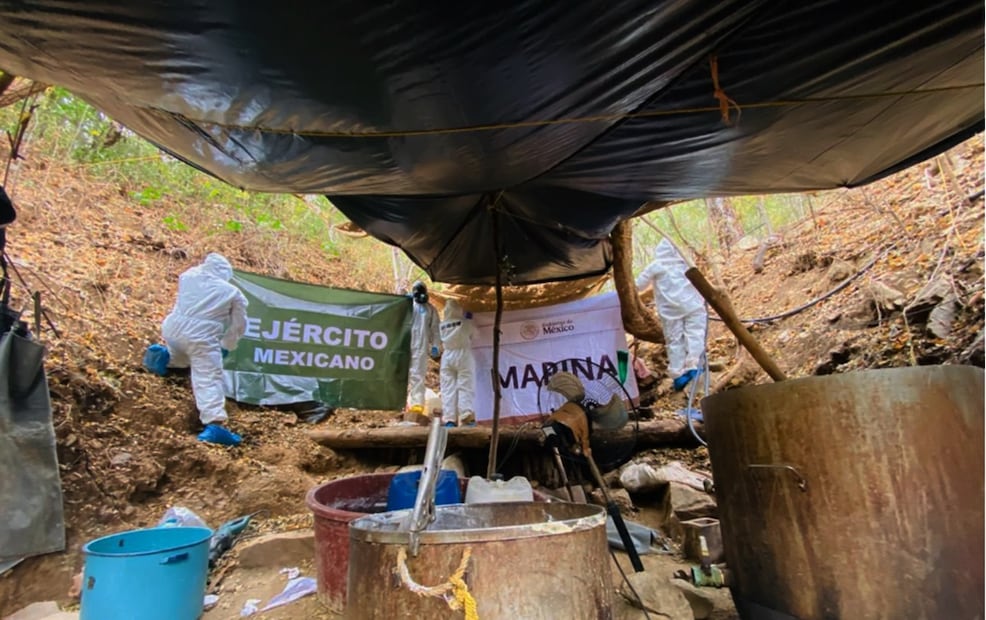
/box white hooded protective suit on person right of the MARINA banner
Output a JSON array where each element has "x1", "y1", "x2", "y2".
[{"x1": 637, "y1": 239, "x2": 708, "y2": 379}]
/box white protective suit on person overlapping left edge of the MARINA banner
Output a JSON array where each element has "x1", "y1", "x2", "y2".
[{"x1": 438, "y1": 299, "x2": 476, "y2": 424}]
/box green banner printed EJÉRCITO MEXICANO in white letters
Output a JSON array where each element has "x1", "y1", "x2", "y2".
[{"x1": 223, "y1": 271, "x2": 411, "y2": 410}]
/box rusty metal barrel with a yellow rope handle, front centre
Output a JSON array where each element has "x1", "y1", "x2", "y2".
[{"x1": 345, "y1": 502, "x2": 613, "y2": 620}]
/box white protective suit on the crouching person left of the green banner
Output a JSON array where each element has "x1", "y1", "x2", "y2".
[{"x1": 161, "y1": 253, "x2": 247, "y2": 424}]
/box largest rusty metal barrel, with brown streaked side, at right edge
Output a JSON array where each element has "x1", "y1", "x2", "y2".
[{"x1": 702, "y1": 366, "x2": 984, "y2": 620}]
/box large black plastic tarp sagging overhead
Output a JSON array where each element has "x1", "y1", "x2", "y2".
[{"x1": 0, "y1": 0, "x2": 984, "y2": 284}]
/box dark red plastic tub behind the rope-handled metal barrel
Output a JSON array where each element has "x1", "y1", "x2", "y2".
[{"x1": 305, "y1": 473, "x2": 394, "y2": 614}]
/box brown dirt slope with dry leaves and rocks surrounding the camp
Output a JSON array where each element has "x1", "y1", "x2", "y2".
[{"x1": 0, "y1": 136, "x2": 984, "y2": 619}]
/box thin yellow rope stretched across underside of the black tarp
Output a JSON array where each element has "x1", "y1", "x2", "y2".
[{"x1": 165, "y1": 82, "x2": 986, "y2": 138}]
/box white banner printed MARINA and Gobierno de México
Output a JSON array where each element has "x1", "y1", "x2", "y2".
[{"x1": 473, "y1": 293, "x2": 638, "y2": 424}]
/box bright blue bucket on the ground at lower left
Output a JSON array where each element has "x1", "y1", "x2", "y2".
[{"x1": 80, "y1": 527, "x2": 212, "y2": 620}]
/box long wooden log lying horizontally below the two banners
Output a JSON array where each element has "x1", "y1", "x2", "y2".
[{"x1": 308, "y1": 419, "x2": 702, "y2": 450}]
